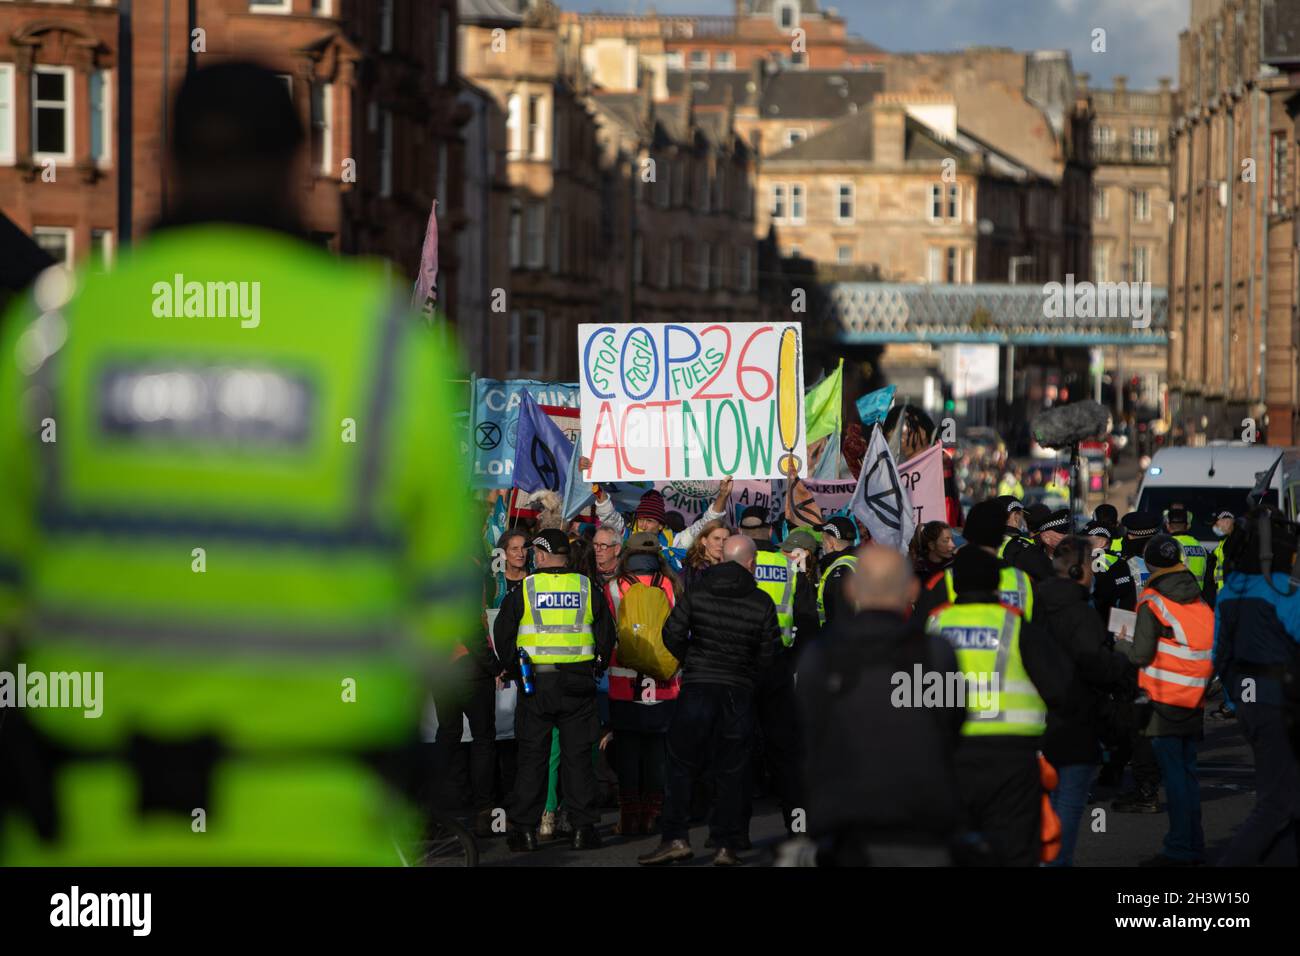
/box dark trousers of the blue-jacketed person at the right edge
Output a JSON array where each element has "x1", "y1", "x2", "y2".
[{"x1": 1219, "y1": 702, "x2": 1300, "y2": 866}]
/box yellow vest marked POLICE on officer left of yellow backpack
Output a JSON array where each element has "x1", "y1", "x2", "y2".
[{"x1": 519, "y1": 571, "x2": 595, "y2": 665}]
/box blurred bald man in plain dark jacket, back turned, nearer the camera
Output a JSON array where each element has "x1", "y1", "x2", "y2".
[{"x1": 796, "y1": 545, "x2": 966, "y2": 866}]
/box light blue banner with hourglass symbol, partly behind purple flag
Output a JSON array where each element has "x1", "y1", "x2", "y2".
[{"x1": 471, "y1": 378, "x2": 579, "y2": 488}]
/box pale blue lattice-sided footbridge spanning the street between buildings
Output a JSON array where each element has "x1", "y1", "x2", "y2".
[{"x1": 822, "y1": 281, "x2": 1169, "y2": 346}]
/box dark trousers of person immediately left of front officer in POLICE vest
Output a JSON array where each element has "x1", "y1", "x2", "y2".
[{"x1": 433, "y1": 676, "x2": 497, "y2": 810}]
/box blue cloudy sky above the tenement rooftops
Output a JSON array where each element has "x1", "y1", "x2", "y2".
[{"x1": 559, "y1": 0, "x2": 1188, "y2": 87}]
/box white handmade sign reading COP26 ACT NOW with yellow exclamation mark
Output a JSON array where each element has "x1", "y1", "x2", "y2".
[{"x1": 577, "y1": 323, "x2": 807, "y2": 481}]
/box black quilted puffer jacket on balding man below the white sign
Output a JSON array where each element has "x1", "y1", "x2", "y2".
[{"x1": 663, "y1": 561, "x2": 781, "y2": 688}]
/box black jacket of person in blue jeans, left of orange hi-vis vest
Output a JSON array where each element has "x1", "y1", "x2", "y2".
[{"x1": 1034, "y1": 578, "x2": 1134, "y2": 767}]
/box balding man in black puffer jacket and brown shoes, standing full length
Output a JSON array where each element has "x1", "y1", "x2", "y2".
[{"x1": 637, "y1": 535, "x2": 781, "y2": 866}]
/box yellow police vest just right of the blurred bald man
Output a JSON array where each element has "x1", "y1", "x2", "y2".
[{"x1": 926, "y1": 604, "x2": 1048, "y2": 737}]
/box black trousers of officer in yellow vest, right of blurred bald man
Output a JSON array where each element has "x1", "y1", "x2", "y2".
[{"x1": 956, "y1": 737, "x2": 1043, "y2": 866}]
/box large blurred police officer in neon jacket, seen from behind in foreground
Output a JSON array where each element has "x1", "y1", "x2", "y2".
[{"x1": 0, "y1": 62, "x2": 477, "y2": 865}]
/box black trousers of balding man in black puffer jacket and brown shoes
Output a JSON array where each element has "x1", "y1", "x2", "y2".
[{"x1": 660, "y1": 684, "x2": 754, "y2": 849}]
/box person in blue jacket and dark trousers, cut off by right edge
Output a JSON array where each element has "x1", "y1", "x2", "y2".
[{"x1": 1214, "y1": 507, "x2": 1300, "y2": 866}]
